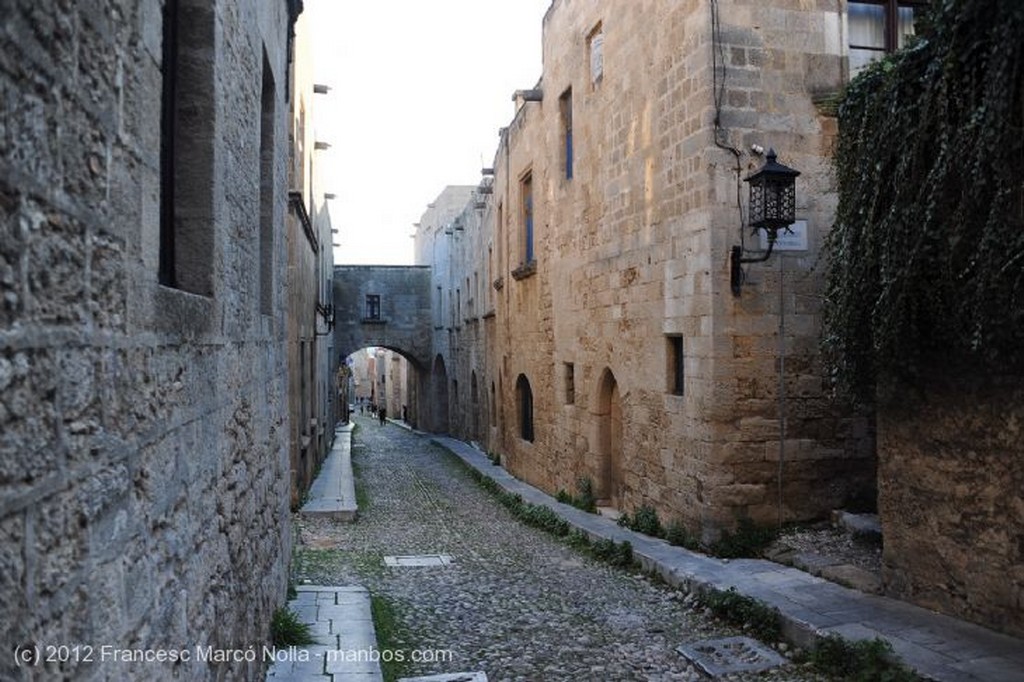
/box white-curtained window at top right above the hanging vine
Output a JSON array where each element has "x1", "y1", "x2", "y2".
[{"x1": 848, "y1": 0, "x2": 927, "y2": 75}]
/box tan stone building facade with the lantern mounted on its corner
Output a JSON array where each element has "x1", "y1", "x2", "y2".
[{"x1": 420, "y1": 0, "x2": 873, "y2": 540}]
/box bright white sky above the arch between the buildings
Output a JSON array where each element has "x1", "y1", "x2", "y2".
[{"x1": 304, "y1": 0, "x2": 551, "y2": 265}]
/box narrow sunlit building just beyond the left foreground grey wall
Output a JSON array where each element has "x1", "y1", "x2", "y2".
[{"x1": 286, "y1": 3, "x2": 335, "y2": 506}]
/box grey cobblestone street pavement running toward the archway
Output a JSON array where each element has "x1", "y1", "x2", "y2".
[{"x1": 293, "y1": 417, "x2": 825, "y2": 682}]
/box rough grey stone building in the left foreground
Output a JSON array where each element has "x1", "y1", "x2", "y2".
[{"x1": 0, "y1": 0, "x2": 301, "y2": 680}]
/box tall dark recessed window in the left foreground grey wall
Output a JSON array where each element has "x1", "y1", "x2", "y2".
[{"x1": 157, "y1": 0, "x2": 215, "y2": 296}]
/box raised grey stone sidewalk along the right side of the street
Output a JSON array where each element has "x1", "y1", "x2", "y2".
[{"x1": 428, "y1": 436, "x2": 1024, "y2": 682}]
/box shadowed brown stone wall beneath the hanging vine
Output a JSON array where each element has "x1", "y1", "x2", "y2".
[{"x1": 879, "y1": 376, "x2": 1024, "y2": 637}]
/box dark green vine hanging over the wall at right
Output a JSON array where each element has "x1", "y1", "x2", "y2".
[{"x1": 823, "y1": 0, "x2": 1024, "y2": 402}]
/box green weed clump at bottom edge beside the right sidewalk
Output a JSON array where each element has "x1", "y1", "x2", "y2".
[{"x1": 810, "y1": 635, "x2": 922, "y2": 682}]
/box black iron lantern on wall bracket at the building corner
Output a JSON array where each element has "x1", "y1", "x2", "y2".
[{"x1": 731, "y1": 150, "x2": 800, "y2": 296}]
